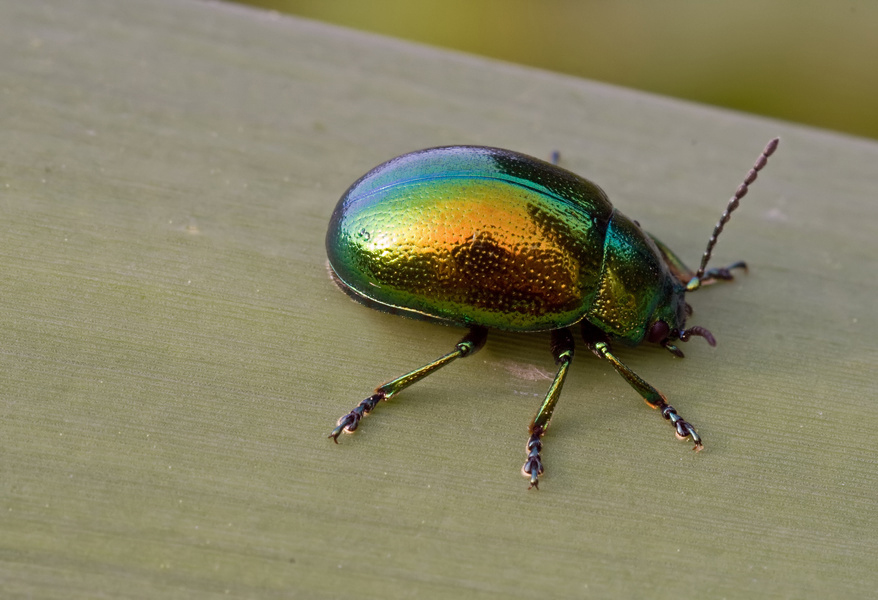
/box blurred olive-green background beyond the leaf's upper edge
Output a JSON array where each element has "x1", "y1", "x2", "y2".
[{"x1": 232, "y1": 0, "x2": 878, "y2": 138}]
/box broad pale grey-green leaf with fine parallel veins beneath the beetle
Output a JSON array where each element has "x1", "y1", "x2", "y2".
[{"x1": 0, "y1": 0, "x2": 878, "y2": 598}]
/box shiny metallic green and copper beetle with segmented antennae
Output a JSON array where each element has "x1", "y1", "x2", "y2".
[{"x1": 326, "y1": 138, "x2": 779, "y2": 488}]
